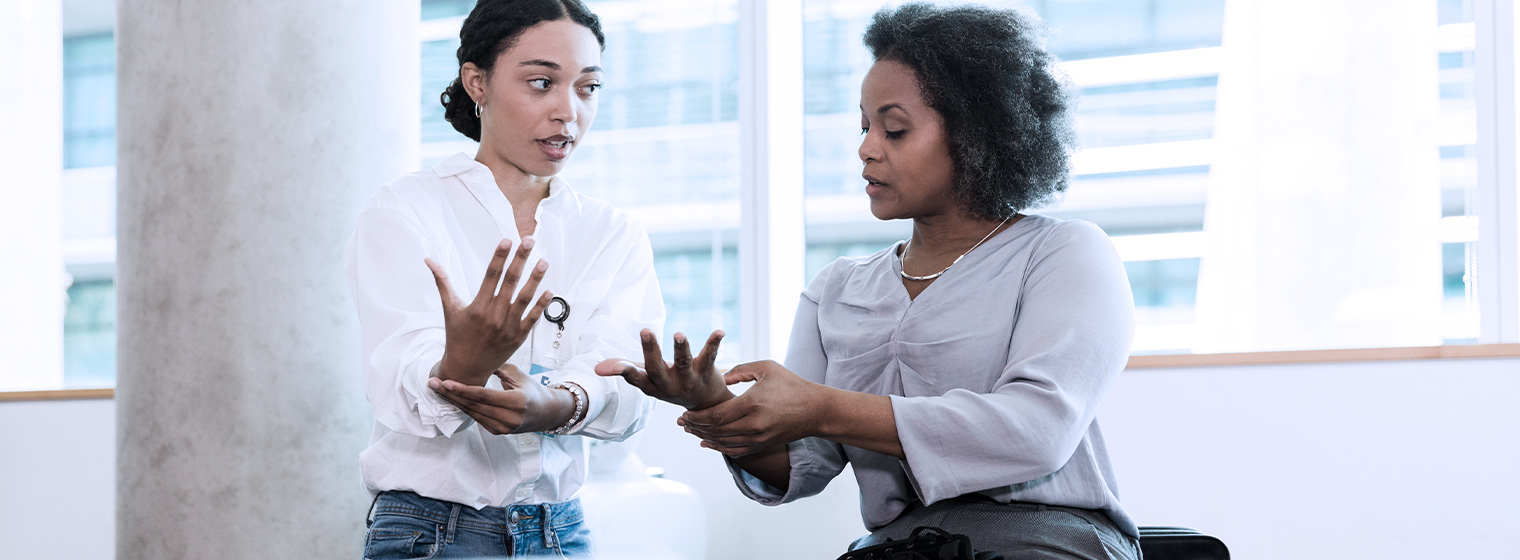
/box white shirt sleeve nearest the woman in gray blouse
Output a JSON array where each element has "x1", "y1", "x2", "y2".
[{"x1": 553, "y1": 224, "x2": 666, "y2": 440}]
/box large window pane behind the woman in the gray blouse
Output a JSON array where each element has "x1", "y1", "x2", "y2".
[{"x1": 804, "y1": 0, "x2": 1477, "y2": 353}]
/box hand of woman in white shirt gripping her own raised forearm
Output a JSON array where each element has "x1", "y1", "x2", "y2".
[{"x1": 427, "y1": 364, "x2": 575, "y2": 435}]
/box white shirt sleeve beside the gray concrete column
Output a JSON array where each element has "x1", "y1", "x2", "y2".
[{"x1": 344, "y1": 207, "x2": 473, "y2": 437}]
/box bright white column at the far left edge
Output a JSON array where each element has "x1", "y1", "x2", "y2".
[{"x1": 0, "y1": 0, "x2": 68, "y2": 391}]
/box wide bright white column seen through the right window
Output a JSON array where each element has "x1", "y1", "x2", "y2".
[{"x1": 1195, "y1": 0, "x2": 1441, "y2": 352}]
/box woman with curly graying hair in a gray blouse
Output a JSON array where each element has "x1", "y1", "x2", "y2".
[{"x1": 597, "y1": 3, "x2": 1140, "y2": 558}]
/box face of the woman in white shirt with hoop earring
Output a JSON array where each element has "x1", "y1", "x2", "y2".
[{"x1": 459, "y1": 20, "x2": 602, "y2": 177}]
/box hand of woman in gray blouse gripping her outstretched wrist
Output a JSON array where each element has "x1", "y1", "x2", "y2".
[{"x1": 676, "y1": 361, "x2": 836, "y2": 457}]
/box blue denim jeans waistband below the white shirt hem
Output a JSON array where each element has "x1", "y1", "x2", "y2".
[{"x1": 369, "y1": 490, "x2": 584, "y2": 534}]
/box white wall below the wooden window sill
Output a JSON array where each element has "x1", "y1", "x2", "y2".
[{"x1": 0, "y1": 358, "x2": 1520, "y2": 560}]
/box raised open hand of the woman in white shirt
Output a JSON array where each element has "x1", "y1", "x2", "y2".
[{"x1": 424, "y1": 237, "x2": 553, "y2": 385}]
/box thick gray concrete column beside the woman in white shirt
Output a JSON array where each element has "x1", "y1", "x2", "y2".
[{"x1": 117, "y1": 0, "x2": 420, "y2": 560}]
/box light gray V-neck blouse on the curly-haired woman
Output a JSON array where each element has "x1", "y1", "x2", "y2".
[{"x1": 730, "y1": 216, "x2": 1138, "y2": 536}]
